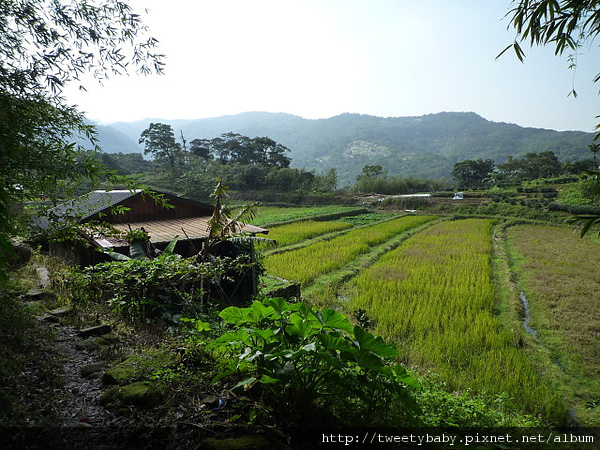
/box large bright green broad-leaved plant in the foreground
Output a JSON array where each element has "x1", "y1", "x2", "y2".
[{"x1": 214, "y1": 298, "x2": 417, "y2": 424}]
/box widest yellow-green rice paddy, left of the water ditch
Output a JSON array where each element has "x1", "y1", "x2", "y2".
[{"x1": 349, "y1": 219, "x2": 565, "y2": 419}]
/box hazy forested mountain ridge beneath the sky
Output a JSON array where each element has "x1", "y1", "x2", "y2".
[{"x1": 100, "y1": 112, "x2": 593, "y2": 186}]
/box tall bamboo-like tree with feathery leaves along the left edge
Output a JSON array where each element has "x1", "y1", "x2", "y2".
[{"x1": 0, "y1": 0, "x2": 162, "y2": 276}]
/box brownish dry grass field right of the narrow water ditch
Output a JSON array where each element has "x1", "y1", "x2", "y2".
[{"x1": 508, "y1": 225, "x2": 600, "y2": 426}]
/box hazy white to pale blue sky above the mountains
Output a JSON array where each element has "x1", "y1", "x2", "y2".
[{"x1": 67, "y1": 0, "x2": 600, "y2": 131}]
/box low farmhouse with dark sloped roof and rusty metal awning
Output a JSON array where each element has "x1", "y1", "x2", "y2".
[{"x1": 35, "y1": 190, "x2": 268, "y2": 266}]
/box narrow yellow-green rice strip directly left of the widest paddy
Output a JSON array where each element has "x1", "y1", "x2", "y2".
[{"x1": 265, "y1": 216, "x2": 435, "y2": 286}]
